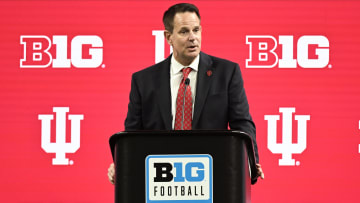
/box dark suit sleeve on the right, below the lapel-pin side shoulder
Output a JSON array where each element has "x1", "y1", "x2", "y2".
[{"x1": 228, "y1": 64, "x2": 259, "y2": 163}]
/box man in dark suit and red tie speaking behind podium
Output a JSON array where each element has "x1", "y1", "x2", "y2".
[{"x1": 108, "y1": 3, "x2": 264, "y2": 183}]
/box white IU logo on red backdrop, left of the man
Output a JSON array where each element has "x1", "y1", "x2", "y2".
[{"x1": 39, "y1": 107, "x2": 84, "y2": 165}]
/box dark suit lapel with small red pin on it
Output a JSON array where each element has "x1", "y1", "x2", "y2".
[{"x1": 192, "y1": 52, "x2": 214, "y2": 129}]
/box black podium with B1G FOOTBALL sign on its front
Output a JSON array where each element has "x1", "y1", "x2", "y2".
[{"x1": 109, "y1": 130, "x2": 258, "y2": 203}]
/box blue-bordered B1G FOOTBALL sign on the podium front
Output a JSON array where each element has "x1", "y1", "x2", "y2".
[{"x1": 146, "y1": 155, "x2": 213, "y2": 203}]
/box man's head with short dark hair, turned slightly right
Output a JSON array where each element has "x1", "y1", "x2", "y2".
[{"x1": 163, "y1": 3, "x2": 201, "y2": 66}]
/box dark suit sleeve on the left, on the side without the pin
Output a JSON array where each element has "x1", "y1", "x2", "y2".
[{"x1": 125, "y1": 74, "x2": 143, "y2": 131}]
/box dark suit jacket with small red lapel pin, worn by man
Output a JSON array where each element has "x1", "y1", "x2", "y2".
[{"x1": 125, "y1": 52, "x2": 259, "y2": 162}]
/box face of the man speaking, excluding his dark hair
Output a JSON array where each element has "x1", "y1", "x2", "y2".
[{"x1": 165, "y1": 12, "x2": 201, "y2": 66}]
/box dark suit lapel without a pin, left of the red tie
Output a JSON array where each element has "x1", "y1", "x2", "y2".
[{"x1": 154, "y1": 55, "x2": 172, "y2": 130}]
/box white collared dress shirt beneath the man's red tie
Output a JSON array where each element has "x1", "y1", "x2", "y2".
[{"x1": 170, "y1": 54, "x2": 200, "y2": 129}]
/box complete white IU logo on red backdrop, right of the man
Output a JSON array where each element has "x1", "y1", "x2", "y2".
[{"x1": 265, "y1": 107, "x2": 310, "y2": 166}]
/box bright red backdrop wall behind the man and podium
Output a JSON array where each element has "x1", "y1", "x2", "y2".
[{"x1": 0, "y1": 0, "x2": 360, "y2": 203}]
